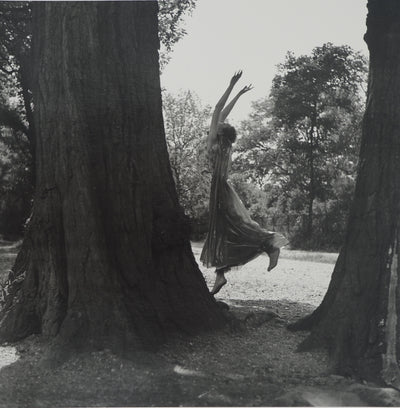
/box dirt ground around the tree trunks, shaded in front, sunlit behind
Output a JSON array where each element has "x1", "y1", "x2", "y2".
[{"x1": 0, "y1": 244, "x2": 400, "y2": 408}]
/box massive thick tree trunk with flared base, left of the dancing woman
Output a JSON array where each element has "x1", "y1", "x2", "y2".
[{"x1": 0, "y1": 1, "x2": 223, "y2": 349}]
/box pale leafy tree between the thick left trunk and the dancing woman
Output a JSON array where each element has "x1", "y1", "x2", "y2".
[{"x1": 163, "y1": 91, "x2": 211, "y2": 226}]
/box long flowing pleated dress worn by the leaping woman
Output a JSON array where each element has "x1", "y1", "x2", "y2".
[{"x1": 200, "y1": 138, "x2": 288, "y2": 268}]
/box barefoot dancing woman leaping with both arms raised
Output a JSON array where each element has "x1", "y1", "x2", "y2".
[{"x1": 200, "y1": 71, "x2": 287, "y2": 294}]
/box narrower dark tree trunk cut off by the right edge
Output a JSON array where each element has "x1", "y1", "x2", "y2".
[{"x1": 292, "y1": 0, "x2": 400, "y2": 387}]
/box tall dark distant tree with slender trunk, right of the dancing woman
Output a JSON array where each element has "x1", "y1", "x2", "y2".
[{"x1": 271, "y1": 43, "x2": 367, "y2": 241}]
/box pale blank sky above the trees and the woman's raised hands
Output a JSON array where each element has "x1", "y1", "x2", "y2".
[{"x1": 161, "y1": 0, "x2": 368, "y2": 122}]
